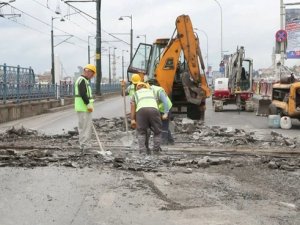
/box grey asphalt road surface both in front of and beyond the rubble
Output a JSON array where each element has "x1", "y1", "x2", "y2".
[{"x1": 0, "y1": 97, "x2": 300, "y2": 225}]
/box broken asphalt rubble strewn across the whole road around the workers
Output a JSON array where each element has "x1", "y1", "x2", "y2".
[{"x1": 0, "y1": 117, "x2": 300, "y2": 173}]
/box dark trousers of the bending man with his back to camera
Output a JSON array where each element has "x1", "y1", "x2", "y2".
[{"x1": 136, "y1": 107, "x2": 162, "y2": 152}]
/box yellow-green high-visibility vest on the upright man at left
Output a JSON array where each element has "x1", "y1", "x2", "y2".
[{"x1": 74, "y1": 76, "x2": 94, "y2": 112}]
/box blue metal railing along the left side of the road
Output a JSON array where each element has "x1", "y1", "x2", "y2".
[{"x1": 0, "y1": 64, "x2": 121, "y2": 104}]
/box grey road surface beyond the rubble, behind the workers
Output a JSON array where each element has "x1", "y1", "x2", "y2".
[{"x1": 0, "y1": 96, "x2": 300, "y2": 137}]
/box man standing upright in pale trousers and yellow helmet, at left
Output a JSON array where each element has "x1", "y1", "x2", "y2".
[{"x1": 74, "y1": 64, "x2": 96, "y2": 151}]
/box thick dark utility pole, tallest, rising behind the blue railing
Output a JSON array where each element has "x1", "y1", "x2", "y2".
[{"x1": 96, "y1": 0, "x2": 102, "y2": 95}]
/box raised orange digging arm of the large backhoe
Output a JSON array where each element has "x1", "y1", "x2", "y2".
[{"x1": 155, "y1": 15, "x2": 210, "y2": 99}]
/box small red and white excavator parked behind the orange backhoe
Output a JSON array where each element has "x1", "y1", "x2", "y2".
[{"x1": 212, "y1": 47, "x2": 254, "y2": 112}]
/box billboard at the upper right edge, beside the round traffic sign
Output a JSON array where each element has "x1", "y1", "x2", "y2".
[{"x1": 285, "y1": 9, "x2": 300, "y2": 59}]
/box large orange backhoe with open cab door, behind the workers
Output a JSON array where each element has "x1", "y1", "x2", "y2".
[{"x1": 127, "y1": 15, "x2": 210, "y2": 120}]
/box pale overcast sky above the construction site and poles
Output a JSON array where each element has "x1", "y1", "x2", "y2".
[{"x1": 0, "y1": 0, "x2": 300, "y2": 77}]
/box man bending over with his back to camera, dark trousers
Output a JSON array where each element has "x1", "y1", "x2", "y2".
[{"x1": 131, "y1": 82, "x2": 162, "y2": 154}]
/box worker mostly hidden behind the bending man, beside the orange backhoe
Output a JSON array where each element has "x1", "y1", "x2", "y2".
[{"x1": 151, "y1": 82, "x2": 174, "y2": 145}]
